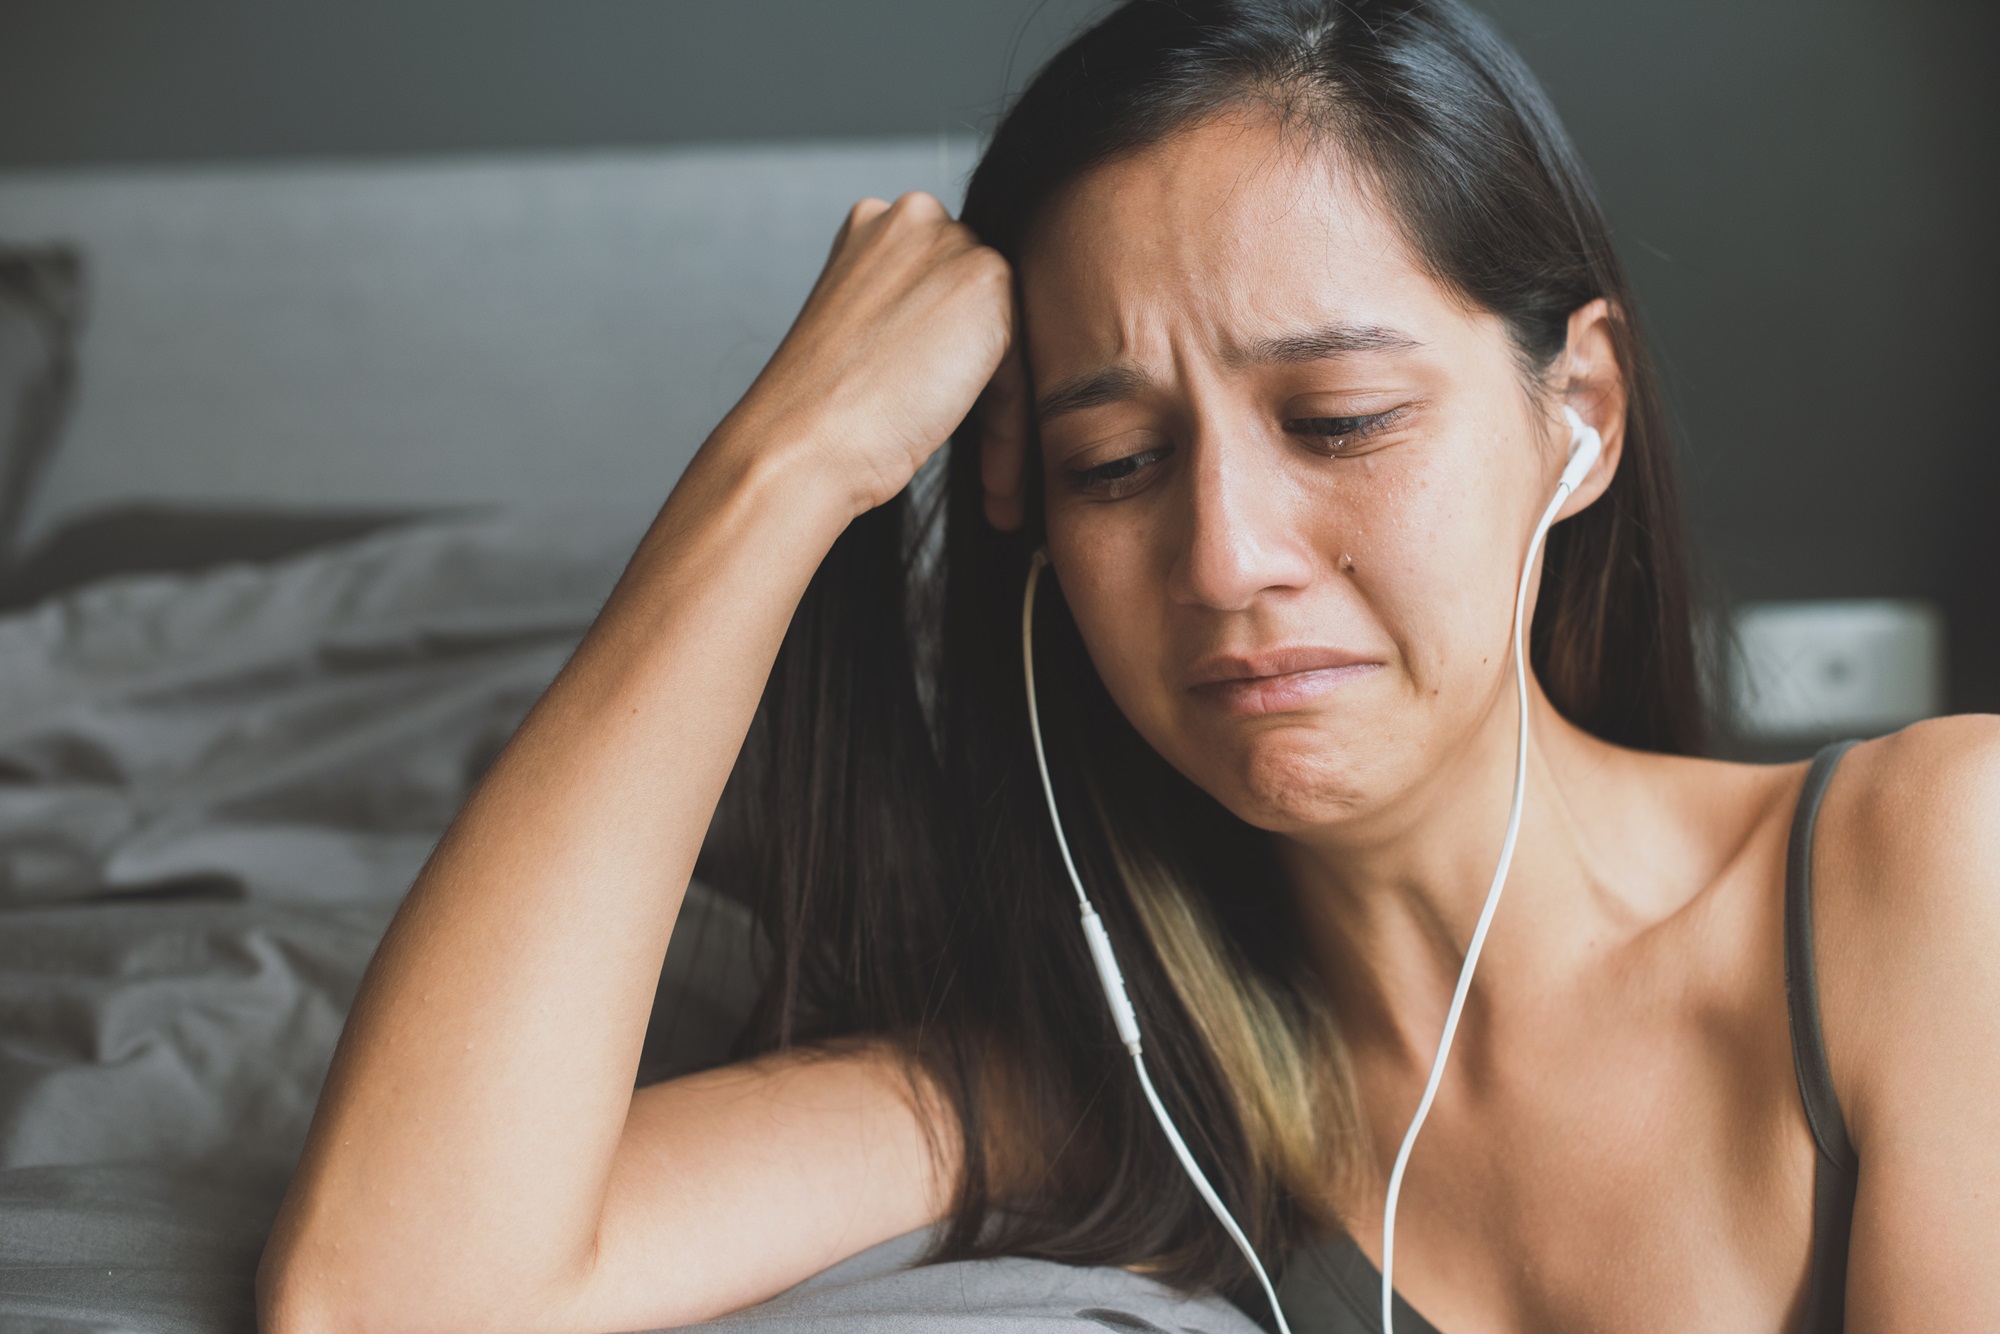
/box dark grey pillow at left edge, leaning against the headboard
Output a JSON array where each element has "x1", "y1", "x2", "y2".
[{"x1": 0, "y1": 246, "x2": 84, "y2": 558}]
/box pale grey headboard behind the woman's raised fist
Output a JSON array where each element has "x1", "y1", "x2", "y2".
[{"x1": 0, "y1": 138, "x2": 974, "y2": 542}]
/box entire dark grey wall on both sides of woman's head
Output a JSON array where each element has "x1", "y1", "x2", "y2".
[{"x1": 0, "y1": 0, "x2": 2000, "y2": 710}]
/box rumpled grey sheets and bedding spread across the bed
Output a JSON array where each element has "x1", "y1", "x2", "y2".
[{"x1": 0, "y1": 514, "x2": 1254, "y2": 1334}]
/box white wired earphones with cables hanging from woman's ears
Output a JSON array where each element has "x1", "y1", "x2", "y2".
[{"x1": 1020, "y1": 406, "x2": 1604, "y2": 1334}]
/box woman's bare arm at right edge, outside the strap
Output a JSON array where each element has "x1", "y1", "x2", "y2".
[{"x1": 1814, "y1": 718, "x2": 2000, "y2": 1334}]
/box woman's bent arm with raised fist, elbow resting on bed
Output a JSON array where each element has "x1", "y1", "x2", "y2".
[{"x1": 258, "y1": 196, "x2": 1012, "y2": 1330}]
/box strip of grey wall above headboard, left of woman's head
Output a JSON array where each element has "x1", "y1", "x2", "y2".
[{"x1": 0, "y1": 0, "x2": 1094, "y2": 166}]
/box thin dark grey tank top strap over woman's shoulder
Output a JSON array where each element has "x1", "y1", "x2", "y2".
[{"x1": 1784, "y1": 742, "x2": 1860, "y2": 1334}]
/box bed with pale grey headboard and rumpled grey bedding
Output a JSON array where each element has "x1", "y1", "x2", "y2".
[{"x1": 0, "y1": 140, "x2": 1254, "y2": 1334}]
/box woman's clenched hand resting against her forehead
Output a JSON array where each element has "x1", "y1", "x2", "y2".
[{"x1": 710, "y1": 194, "x2": 1014, "y2": 518}]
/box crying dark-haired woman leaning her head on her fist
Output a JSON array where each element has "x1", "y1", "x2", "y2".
[{"x1": 260, "y1": 0, "x2": 2000, "y2": 1332}]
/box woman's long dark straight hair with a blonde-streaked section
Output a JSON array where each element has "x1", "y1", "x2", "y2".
[{"x1": 708, "y1": 0, "x2": 1700, "y2": 1286}]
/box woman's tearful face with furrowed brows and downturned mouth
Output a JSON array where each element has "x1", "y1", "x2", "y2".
[{"x1": 1020, "y1": 116, "x2": 1566, "y2": 832}]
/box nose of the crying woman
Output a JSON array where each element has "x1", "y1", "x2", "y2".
[{"x1": 1168, "y1": 430, "x2": 1312, "y2": 612}]
